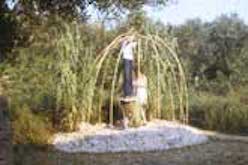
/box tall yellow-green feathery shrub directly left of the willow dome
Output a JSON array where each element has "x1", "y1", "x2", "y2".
[{"x1": 3, "y1": 21, "x2": 100, "y2": 131}]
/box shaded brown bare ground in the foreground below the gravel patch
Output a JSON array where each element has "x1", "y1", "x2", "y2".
[{"x1": 15, "y1": 140, "x2": 248, "y2": 165}]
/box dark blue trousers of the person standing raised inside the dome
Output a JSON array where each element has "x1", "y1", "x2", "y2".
[{"x1": 123, "y1": 59, "x2": 133, "y2": 97}]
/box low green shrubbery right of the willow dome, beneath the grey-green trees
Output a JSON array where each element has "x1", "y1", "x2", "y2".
[{"x1": 190, "y1": 87, "x2": 248, "y2": 134}]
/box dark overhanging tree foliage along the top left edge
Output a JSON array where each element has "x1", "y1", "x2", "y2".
[{"x1": 0, "y1": 0, "x2": 167, "y2": 60}]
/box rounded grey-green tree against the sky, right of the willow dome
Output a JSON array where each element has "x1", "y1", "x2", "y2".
[{"x1": 174, "y1": 14, "x2": 248, "y2": 84}]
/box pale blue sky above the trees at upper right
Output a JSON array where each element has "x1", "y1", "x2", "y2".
[{"x1": 145, "y1": 0, "x2": 248, "y2": 25}]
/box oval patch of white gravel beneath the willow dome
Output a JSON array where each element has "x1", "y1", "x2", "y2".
[{"x1": 53, "y1": 120, "x2": 208, "y2": 153}]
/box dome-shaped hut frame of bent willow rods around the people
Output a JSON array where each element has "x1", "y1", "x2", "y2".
[{"x1": 90, "y1": 31, "x2": 188, "y2": 124}]
